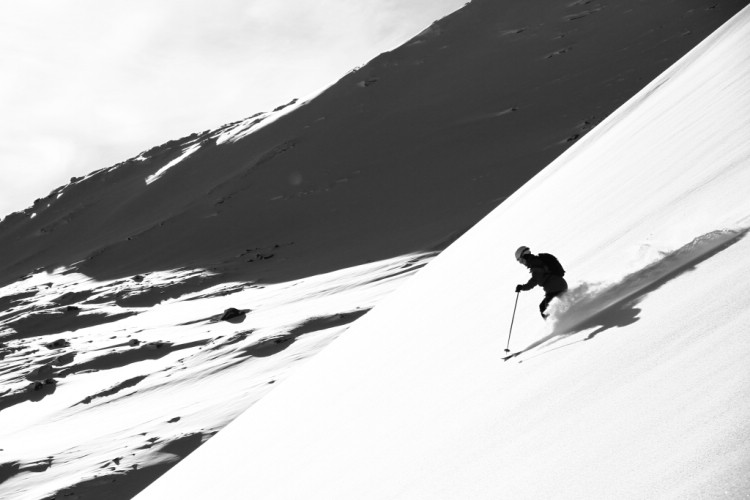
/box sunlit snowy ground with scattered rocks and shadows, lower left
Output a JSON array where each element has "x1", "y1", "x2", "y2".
[{"x1": 0, "y1": 254, "x2": 433, "y2": 500}]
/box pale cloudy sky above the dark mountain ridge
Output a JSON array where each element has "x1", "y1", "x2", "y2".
[{"x1": 0, "y1": 0, "x2": 465, "y2": 217}]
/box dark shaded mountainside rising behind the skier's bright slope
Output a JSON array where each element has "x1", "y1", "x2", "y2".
[{"x1": 0, "y1": 0, "x2": 744, "y2": 283}]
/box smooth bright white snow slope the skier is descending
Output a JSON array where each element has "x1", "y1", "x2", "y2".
[{"x1": 138, "y1": 8, "x2": 750, "y2": 500}]
